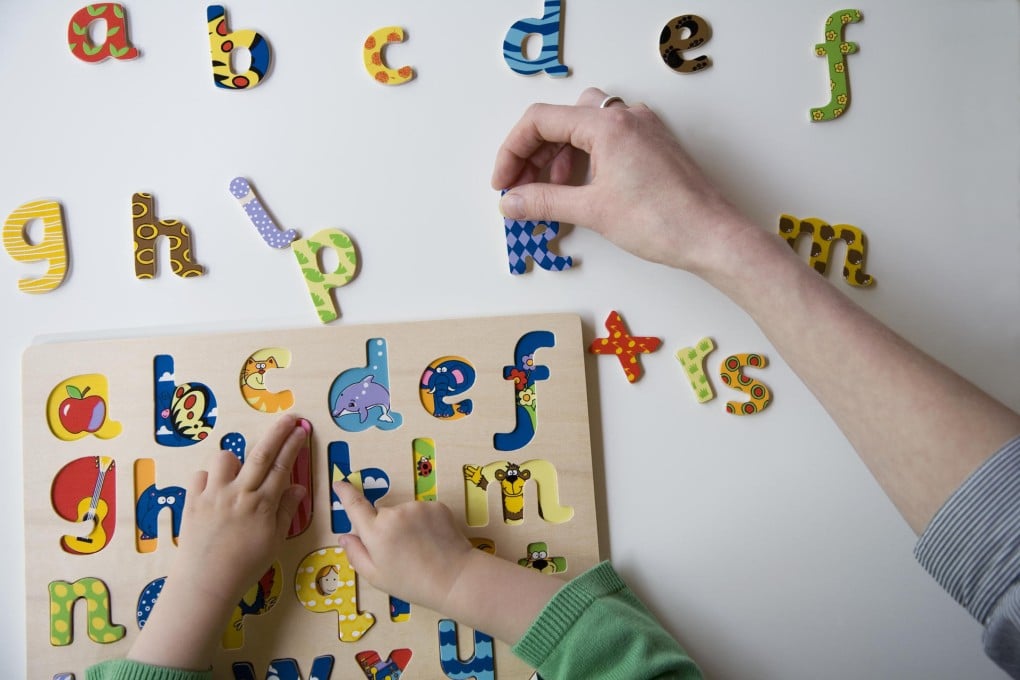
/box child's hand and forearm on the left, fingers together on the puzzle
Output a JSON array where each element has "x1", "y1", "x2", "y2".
[{"x1": 128, "y1": 416, "x2": 311, "y2": 670}]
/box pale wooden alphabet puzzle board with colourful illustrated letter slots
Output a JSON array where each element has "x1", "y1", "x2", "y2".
[{"x1": 22, "y1": 315, "x2": 599, "y2": 680}]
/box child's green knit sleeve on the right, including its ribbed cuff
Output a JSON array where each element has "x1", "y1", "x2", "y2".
[{"x1": 513, "y1": 562, "x2": 702, "y2": 680}]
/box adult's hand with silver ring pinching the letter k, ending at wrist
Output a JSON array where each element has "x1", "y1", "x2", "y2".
[{"x1": 492, "y1": 88, "x2": 758, "y2": 275}]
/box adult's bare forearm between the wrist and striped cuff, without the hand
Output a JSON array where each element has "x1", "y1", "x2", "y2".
[{"x1": 703, "y1": 222, "x2": 1020, "y2": 532}]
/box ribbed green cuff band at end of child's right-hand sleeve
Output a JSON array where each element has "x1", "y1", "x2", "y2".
[{"x1": 511, "y1": 562, "x2": 627, "y2": 668}]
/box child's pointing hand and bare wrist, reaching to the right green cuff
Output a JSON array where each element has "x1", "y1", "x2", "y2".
[{"x1": 333, "y1": 482, "x2": 563, "y2": 644}]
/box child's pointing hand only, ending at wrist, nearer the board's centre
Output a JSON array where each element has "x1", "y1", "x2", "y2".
[{"x1": 333, "y1": 481, "x2": 472, "y2": 611}]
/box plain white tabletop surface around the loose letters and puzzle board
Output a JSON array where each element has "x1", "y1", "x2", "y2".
[{"x1": 0, "y1": 0, "x2": 1020, "y2": 680}]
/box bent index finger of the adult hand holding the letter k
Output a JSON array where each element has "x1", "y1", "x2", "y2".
[{"x1": 492, "y1": 104, "x2": 599, "y2": 189}]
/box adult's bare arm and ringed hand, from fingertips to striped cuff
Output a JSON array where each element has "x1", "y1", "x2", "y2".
[{"x1": 492, "y1": 89, "x2": 1020, "y2": 532}]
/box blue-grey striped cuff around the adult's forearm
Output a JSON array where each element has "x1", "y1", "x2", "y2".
[{"x1": 914, "y1": 436, "x2": 1020, "y2": 625}]
